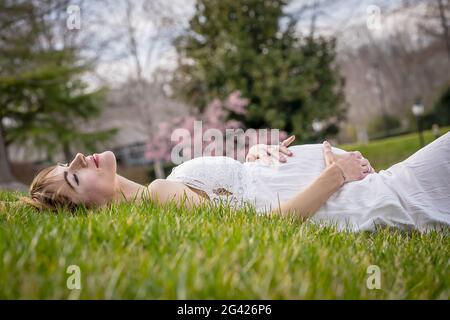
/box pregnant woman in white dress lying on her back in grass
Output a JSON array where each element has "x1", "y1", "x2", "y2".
[{"x1": 19, "y1": 133, "x2": 450, "y2": 231}]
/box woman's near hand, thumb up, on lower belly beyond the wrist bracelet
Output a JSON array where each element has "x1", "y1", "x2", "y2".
[{"x1": 323, "y1": 141, "x2": 374, "y2": 183}]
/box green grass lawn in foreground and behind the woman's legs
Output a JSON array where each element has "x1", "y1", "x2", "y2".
[{"x1": 0, "y1": 128, "x2": 450, "y2": 299}]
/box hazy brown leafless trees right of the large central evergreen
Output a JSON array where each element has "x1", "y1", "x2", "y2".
[{"x1": 338, "y1": 0, "x2": 450, "y2": 142}]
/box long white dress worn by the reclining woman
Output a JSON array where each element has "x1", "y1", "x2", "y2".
[{"x1": 167, "y1": 132, "x2": 450, "y2": 231}]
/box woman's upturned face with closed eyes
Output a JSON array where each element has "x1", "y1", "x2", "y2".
[{"x1": 53, "y1": 151, "x2": 116, "y2": 205}]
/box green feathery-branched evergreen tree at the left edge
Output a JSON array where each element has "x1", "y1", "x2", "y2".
[{"x1": 0, "y1": 1, "x2": 115, "y2": 186}]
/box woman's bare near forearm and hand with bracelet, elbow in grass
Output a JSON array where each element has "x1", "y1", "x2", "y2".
[{"x1": 270, "y1": 144, "x2": 370, "y2": 218}]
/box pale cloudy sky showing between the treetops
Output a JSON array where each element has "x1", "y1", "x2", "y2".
[{"x1": 86, "y1": 0, "x2": 408, "y2": 86}]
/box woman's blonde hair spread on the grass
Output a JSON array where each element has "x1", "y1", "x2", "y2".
[{"x1": 19, "y1": 165, "x2": 78, "y2": 211}]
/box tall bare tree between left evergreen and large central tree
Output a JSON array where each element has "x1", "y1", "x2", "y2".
[{"x1": 99, "y1": 0, "x2": 184, "y2": 178}]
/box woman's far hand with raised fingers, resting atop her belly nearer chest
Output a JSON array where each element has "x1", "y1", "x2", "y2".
[{"x1": 245, "y1": 136, "x2": 295, "y2": 164}]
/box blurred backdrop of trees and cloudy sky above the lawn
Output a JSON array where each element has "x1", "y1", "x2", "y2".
[{"x1": 0, "y1": 0, "x2": 450, "y2": 190}]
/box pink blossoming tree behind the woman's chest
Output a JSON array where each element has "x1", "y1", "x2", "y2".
[{"x1": 146, "y1": 91, "x2": 287, "y2": 178}]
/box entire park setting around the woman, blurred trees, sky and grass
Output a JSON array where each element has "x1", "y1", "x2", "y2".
[{"x1": 0, "y1": 0, "x2": 450, "y2": 300}]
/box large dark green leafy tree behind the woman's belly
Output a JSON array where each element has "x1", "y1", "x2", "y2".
[{"x1": 173, "y1": 0, "x2": 345, "y2": 141}]
